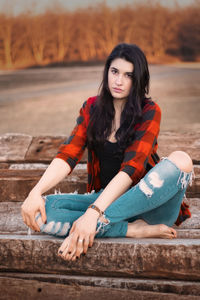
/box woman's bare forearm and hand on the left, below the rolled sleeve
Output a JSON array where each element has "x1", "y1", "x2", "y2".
[{"x1": 21, "y1": 158, "x2": 71, "y2": 231}]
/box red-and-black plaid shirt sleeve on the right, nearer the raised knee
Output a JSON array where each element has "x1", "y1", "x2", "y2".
[{"x1": 120, "y1": 100, "x2": 161, "y2": 184}]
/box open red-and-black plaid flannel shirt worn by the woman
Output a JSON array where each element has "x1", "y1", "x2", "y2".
[{"x1": 56, "y1": 97, "x2": 190, "y2": 225}]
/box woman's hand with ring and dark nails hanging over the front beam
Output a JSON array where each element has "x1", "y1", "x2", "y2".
[{"x1": 58, "y1": 209, "x2": 99, "y2": 261}]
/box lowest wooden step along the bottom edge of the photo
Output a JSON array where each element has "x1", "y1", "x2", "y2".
[{"x1": 0, "y1": 273, "x2": 200, "y2": 300}]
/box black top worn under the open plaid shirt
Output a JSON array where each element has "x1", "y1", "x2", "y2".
[{"x1": 96, "y1": 141, "x2": 124, "y2": 188}]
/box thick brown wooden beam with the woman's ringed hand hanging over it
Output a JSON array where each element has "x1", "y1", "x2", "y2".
[{"x1": 0, "y1": 235, "x2": 200, "y2": 281}]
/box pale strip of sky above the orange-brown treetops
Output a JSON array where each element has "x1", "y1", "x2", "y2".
[{"x1": 0, "y1": 0, "x2": 195, "y2": 15}]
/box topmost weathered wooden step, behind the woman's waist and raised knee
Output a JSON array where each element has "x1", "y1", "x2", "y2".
[{"x1": 0, "y1": 131, "x2": 200, "y2": 164}]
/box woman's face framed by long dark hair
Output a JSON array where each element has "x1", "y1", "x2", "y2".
[{"x1": 108, "y1": 58, "x2": 134, "y2": 99}]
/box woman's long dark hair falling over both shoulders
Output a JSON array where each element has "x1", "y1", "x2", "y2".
[{"x1": 87, "y1": 43, "x2": 149, "y2": 151}]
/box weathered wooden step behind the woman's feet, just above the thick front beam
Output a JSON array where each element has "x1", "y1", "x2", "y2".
[{"x1": 0, "y1": 198, "x2": 200, "y2": 238}]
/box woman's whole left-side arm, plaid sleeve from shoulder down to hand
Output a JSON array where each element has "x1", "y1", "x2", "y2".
[{"x1": 21, "y1": 97, "x2": 91, "y2": 231}]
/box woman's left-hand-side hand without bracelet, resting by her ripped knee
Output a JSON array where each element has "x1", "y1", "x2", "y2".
[{"x1": 21, "y1": 191, "x2": 46, "y2": 231}]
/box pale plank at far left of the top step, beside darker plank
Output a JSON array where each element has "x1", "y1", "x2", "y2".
[{"x1": 0, "y1": 133, "x2": 32, "y2": 162}]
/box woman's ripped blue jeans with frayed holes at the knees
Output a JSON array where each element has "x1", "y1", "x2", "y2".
[{"x1": 36, "y1": 158, "x2": 192, "y2": 237}]
